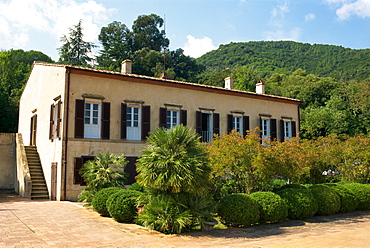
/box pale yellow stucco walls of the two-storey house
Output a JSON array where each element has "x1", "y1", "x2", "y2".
[{"x1": 19, "y1": 63, "x2": 300, "y2": 200}]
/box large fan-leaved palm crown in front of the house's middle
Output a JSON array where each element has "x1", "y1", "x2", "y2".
[{"x1": 136, "y1": 125, "x2": 210, "y2": 195}]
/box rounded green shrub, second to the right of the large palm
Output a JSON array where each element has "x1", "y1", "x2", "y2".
[{"x1": 250, "y1": 192, "x2": 288, "y2": 223}]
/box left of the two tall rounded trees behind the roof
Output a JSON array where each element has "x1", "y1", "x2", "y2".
[{"x1": 97, "y1": 21, "x2": 134, "y2": 70}]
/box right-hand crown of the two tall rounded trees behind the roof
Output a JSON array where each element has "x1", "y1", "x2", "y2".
[{"x1": 132, "y1": 14, "x2": 170, "y2": 51}]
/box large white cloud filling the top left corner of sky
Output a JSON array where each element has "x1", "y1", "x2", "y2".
[{"x1": 0, "y1": 0, "x2": 113, "y2": 49}]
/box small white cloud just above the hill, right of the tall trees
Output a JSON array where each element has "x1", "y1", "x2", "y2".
[{"x1": 183, "y1": 35, "x2": 217, "y2": 58}]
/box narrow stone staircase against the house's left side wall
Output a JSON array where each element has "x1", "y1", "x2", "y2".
[{"x1": 25, "y1": 146, "x2": 49, "y2": 199}]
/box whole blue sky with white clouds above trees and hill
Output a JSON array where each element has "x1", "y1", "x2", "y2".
[{"x1": 0, "y1": 0, "x2": 370, "y2": 61}]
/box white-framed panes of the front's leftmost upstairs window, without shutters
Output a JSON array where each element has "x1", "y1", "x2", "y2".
[{"x1": 84, "y1": 100, "x2": 101, "y2": 139}]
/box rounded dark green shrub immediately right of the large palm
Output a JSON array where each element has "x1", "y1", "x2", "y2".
[{"x1": 217, "y1": 193, "x2": 260, "y2": 227}]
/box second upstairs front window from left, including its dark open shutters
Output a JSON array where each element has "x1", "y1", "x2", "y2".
[{"x1": 121, "y1": 103, "x2": 150, "y2": 140}]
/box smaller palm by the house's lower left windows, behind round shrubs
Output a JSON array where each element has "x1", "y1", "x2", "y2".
[{"x1": 79, "y1": 152, "x2": 128, "y2": 202}]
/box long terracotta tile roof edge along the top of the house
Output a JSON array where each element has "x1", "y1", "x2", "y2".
[{"x1": 34, "y1": 61, "x2": 301, "y2": 104}]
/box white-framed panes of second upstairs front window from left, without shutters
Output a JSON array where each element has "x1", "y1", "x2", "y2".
[{"x1": 126, "y1": 104, "x2": 142, "y2": 140}]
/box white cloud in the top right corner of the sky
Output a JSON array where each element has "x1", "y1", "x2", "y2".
[{"x1": 326, "y1": 0, "x2": 370, "y2": 20}]
